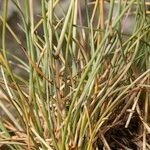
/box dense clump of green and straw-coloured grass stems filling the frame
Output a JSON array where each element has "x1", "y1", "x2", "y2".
[{"x1": 0, "y1": 0, "x2": 150, "y2": 150}]
